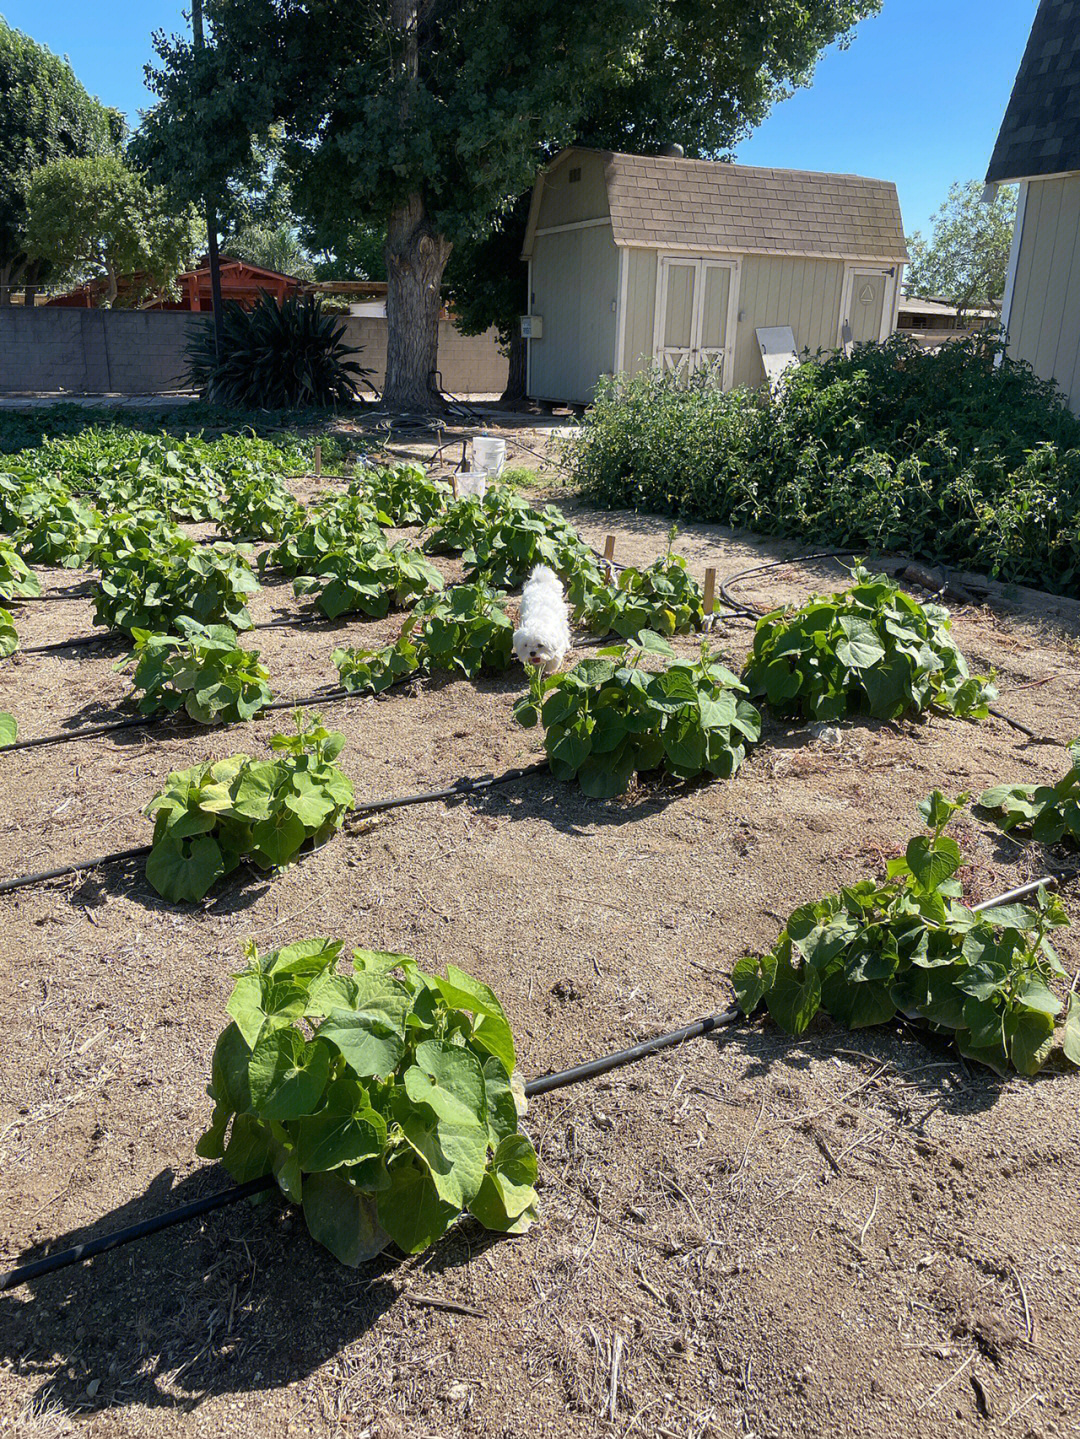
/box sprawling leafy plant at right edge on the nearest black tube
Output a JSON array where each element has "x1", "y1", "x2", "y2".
[{"x1": 732, "y1": 790, "x2": 1080, "y2": 1073}]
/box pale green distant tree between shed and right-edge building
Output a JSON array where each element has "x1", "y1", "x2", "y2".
[{"x1": 906, "y1": 180, "x2": 1017, "y2": 315}]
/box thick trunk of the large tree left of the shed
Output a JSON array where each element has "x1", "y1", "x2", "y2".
[{"x1": 383, "y1": 194, "x2": 452, "y2": 410}]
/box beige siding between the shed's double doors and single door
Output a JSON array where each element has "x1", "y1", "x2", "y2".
[{"x1": 733, "y1": 255, "x2": 844, "y2": 386}]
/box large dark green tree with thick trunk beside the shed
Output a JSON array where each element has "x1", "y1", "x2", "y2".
[{"x1": 142, "y1": 0, "x2": 880, "y2": 407}]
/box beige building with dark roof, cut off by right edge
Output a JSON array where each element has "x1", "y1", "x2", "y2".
[{"x1": 987, "y1": 0, "x2": 1080, "y2": 414}]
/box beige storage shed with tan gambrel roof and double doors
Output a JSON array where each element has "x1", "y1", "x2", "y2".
[{"x1": 523, "y1": 148, "x2": 907, "y2": 404}]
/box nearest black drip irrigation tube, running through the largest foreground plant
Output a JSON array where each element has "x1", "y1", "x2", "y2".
[{"x1": 0, "y1": 878, "x2": 1056, "y2": 1292}]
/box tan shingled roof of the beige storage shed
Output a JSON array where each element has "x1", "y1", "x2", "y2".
[{"x1": 525, "y1": 150, "x2": 907, "y2": 263}]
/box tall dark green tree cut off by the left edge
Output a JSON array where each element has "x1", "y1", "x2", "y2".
[{"x1": 0, "y1": 16, "x2": 124, "y2": 304}]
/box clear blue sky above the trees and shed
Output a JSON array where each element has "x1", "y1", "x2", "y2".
[{"x1": 0, "y1": 0, "x2": 1035, "y2": 233}]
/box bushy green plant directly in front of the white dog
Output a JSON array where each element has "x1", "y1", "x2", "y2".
[{"x1": 513, "y1": 630, "x2": 761, "y2": 799}]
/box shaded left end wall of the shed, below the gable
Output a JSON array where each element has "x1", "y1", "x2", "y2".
[{"x1": 529, "y1": 226, "x2": 618, "y2": 404}]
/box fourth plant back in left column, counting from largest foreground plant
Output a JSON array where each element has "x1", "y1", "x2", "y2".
[{"x1": 93, "y1": 537, "x2": 259, "y2": 633}]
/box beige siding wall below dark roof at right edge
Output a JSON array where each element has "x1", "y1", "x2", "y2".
[{"x1": 1008, "y1": 176, "x2": 1080, "y2": 414}]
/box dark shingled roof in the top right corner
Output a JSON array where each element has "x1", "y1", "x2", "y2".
[{"x1": 987, "y1": 0, "x2": 1080, "y2": 183}]
